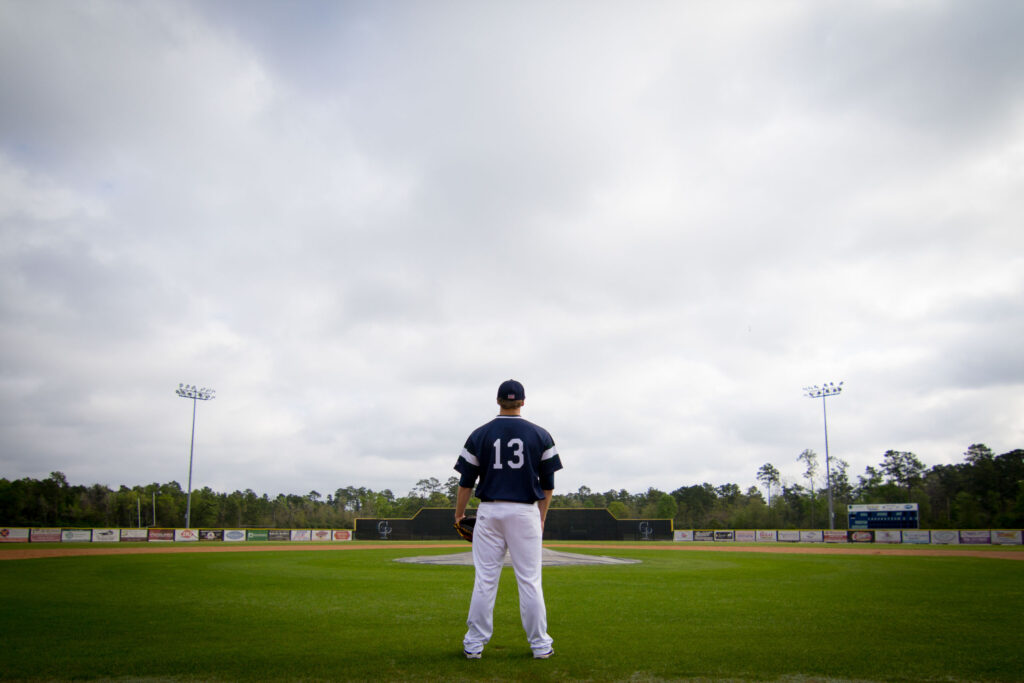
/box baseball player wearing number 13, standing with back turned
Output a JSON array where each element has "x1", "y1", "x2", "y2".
[{"x1": 455, "y1": 380, "x2": 562, "y2": 659}]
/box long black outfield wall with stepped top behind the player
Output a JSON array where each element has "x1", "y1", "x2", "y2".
[{"x1": 354, "y1": 508, "x2": 673, "y2": 541}]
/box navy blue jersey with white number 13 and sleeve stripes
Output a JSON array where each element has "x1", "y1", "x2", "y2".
[{"x1": 455, "y1": 415, "x2": 562, "y2": 503}]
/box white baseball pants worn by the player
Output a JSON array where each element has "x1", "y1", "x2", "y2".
[{"x1": 463, "y1": 503, "x2": 552, "y2": 653}]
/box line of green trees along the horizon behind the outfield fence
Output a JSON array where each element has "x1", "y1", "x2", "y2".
[{"x1": 0, "y1": 443, "x2": 1024, "y2": 529}]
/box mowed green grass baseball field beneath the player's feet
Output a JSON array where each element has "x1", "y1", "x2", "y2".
[{"x1": 0, "y1": 545, "x2": 1024, "y2": 681}]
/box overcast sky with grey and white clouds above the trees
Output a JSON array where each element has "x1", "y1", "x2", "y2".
[{"x1": 0, "y1": 0, "x2": 1024, "y2": 496}]
